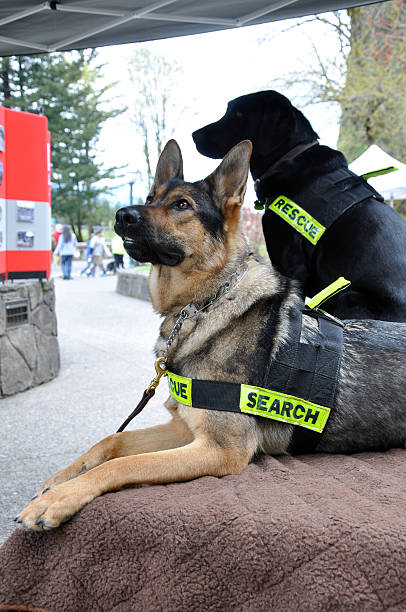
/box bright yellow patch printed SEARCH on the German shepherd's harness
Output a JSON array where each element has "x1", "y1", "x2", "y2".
[{"x1": 240, "y1": 385, "x2": 330, "y2": 433}]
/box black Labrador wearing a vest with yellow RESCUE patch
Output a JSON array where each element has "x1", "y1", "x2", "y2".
[{"x1": 193, "y1": 91, "x2": 406, "y2": 321}]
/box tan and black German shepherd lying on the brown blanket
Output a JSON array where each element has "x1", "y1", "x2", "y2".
[{"x1": 16, "y1": 140, "x2": 406, "y2": 531}]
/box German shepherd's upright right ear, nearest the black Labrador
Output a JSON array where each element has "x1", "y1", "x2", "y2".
[{"x1": 206, "y1": 140, "x2": 252, "y2": 212}]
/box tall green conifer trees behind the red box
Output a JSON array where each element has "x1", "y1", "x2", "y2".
[{"x1": 0, "y1": 50, "x2": 121, "y2": 240}]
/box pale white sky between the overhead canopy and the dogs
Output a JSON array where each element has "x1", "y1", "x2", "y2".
[{"x1": 93, "y1": 14, "x2": 339, "y2": 205}]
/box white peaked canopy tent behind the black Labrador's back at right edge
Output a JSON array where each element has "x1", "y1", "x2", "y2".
[{"x1": 349, "y1": 145, "x2": 406, "y2": 202}]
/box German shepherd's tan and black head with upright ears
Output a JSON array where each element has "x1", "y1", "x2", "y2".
[{"x1": 114, "y1": 140, "x2": 252, "y2": 271}]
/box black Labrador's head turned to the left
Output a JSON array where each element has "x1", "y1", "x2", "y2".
[{"x1": 192, "y1": 91, "x2": 318, "y2": 177}]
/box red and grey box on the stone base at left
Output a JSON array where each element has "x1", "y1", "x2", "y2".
[{"x1": 0, "y1": 106, "x2": 51, "y2": 279}]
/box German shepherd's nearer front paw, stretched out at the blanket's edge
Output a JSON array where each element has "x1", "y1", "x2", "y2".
[{"x1": 14, "y1": 480, "x2": 95, "y2": 531}]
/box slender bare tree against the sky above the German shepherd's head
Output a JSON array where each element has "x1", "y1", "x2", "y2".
[{"x1": 128, "y1": 47, "x2": 185, "y2": 187}]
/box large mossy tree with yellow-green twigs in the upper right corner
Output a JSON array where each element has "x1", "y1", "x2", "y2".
[{"x1": 262, "y1": 0, "x2": 406, "y2": 161}]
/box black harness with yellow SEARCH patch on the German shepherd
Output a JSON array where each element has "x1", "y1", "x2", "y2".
[{"x1": 168, "y1": 308, "x2": 343, "y2": 454}]
